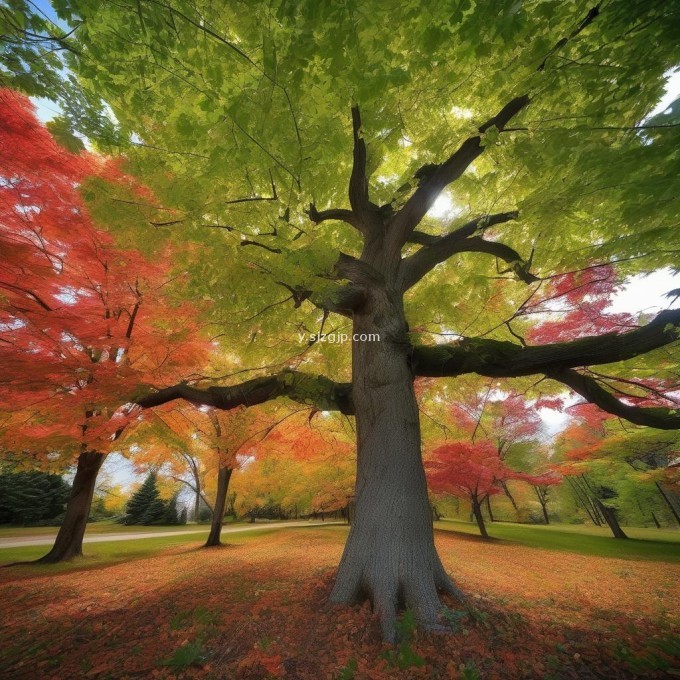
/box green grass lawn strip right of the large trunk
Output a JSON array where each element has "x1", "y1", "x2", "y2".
[{"x1": 435, "y1": 519, "x2": 680, "y2": 562}]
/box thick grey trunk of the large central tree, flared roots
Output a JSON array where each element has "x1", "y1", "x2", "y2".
[{"x1": 331, "y1": 291, "x2": 462, "y2": 642}]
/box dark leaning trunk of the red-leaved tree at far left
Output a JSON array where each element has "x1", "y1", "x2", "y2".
[{"x1": 37, "y1": 451, "x2": 106, "y2": 564}]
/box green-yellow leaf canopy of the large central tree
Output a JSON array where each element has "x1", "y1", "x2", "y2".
[{"x1": 8, "y1": 0, "x2": 668, "y2": 375}]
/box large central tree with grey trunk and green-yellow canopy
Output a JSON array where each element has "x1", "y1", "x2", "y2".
[{"x1": 5, "y1": 0, "x2": 680, "y2": 639}]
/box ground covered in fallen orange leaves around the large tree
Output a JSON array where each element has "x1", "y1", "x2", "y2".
[{"x1": 0, "y1": 527, "x2": 680, "y2": 680}]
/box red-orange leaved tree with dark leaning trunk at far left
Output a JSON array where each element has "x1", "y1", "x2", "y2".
[{"x1": 0, "y1": 90, "x2": 211, "y2": 562}]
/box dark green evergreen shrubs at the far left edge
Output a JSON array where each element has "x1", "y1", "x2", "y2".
[{"x1": 0, "y1": 471, "x2": 71, "y2": 526}]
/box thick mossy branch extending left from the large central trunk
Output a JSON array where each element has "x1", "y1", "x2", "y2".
[{"x1": 135, "y1": 371, "x2": 354, "y2": 415}]
